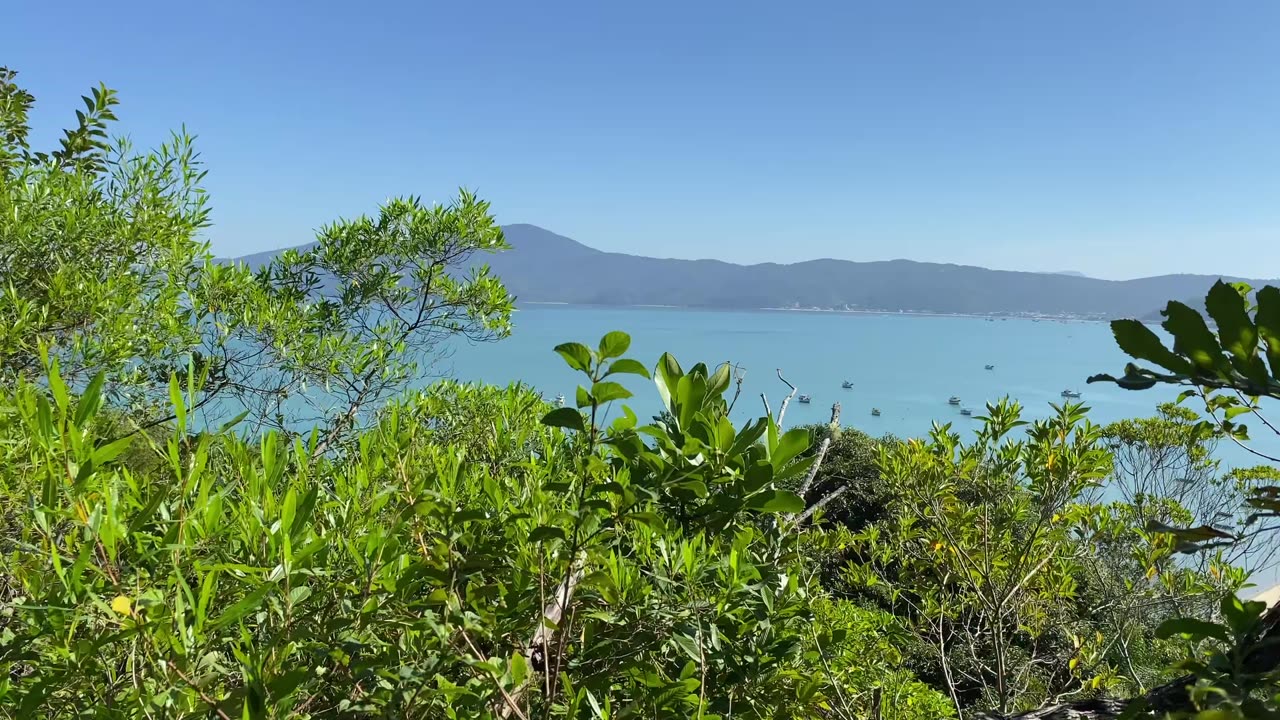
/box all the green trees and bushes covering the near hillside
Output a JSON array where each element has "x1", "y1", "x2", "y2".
[{"x1": 0, "y1": 70, "x2": 1280, "y2": 720}]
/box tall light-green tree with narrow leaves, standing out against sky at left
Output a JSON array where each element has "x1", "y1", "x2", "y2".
[{"x1": 0, "y1": 68, "x2": 511, "y2": 451}]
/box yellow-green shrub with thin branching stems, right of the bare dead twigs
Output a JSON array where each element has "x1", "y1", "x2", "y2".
[{"x1": 849, "y1": 402, "x2": 1108, "y2": 712}]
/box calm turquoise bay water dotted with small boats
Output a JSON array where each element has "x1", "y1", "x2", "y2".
[{"x1": 433, "y1": 305, "x2": 1276, "y2": 465}]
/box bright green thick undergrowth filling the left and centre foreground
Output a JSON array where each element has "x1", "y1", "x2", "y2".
[{"x1": 0, "y1": 336, "x2": 890, "y2": 717}]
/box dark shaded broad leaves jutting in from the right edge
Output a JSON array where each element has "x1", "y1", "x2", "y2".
[{"x1": 1089, "y1": 282, "x2": 1280, "y2": 717}]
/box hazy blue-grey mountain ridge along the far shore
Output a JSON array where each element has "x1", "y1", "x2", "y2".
[{"x1": 225, "y1": 224, "x2": 1275, "y2": 318}]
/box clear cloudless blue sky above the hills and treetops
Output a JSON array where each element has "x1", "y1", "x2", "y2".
[{"x1": 10, "y1": 0, "x2": 1280, "y2": 277}]
